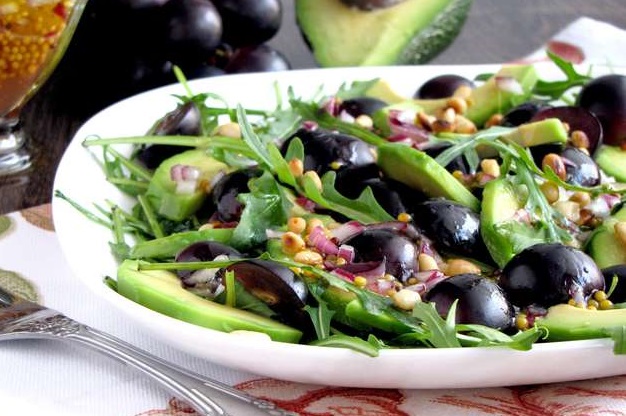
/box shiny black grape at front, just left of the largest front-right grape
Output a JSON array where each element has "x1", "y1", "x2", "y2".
[{"x1": 426, "y1": 274, "x2": 515, "y2": 331}]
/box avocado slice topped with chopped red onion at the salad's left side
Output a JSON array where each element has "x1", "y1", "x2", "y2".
[{"x1": 146, "y1": 149, "x2": 230, "y2": 221}]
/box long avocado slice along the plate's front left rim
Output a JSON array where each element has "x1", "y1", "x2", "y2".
[{"x1": 117, "y1": 260, "x2": 302, "y2": 343}]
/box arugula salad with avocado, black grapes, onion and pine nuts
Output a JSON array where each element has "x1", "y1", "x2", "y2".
[{"x1": 57, "y1": 56, "x2": 626, "y2": 356}]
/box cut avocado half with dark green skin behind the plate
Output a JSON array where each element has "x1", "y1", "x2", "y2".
[{"x1": 296, "y1": 0, "x2": 472, "y2": 67}]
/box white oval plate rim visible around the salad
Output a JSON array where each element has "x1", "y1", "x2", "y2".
[{"x1": 53, "y1": 65, "x2": 626, "y2": 389}]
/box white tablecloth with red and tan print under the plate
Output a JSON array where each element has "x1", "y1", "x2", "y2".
[{"x1": 0, "y1": 18, "x2": 626, "y2": 416}]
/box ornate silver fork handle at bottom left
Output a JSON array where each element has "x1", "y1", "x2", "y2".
[{"x1": 14, "y1": 310, "x2": 297, "y2": 416}]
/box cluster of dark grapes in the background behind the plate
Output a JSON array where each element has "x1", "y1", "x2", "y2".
[{"x1": 62, "y1": 0, "x2": 290, "y2": 112}]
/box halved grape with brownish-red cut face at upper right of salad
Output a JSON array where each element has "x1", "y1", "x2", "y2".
[{"x1": 530, "y1": 106, "x2": 604, "y2": 155}]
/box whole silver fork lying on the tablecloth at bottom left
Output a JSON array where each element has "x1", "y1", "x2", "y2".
[{"x1": 0, "y1": 288, "x2": 297, "y2": 416}]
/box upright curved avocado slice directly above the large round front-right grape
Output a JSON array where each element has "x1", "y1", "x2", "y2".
[{"x1": 480, "y1": 178, "x2": 547, "y2": 267}]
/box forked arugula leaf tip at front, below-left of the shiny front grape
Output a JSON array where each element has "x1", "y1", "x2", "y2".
[{"x1": 413, "y1": 301, "x2": 461, "y2": 348}]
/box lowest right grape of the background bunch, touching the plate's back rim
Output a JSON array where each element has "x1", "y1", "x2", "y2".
[{"x1": 224, "y1": 44, "x2": 291, "y2": 74}]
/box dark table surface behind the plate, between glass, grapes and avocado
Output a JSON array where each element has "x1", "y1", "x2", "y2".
[{"x1": 0, "y1": 0, "x2": 626, "y2": 214}]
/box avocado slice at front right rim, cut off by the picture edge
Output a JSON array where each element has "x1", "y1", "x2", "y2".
[{"x1": 535, "y1": 304, "x2": 626, "y2": 341}]
